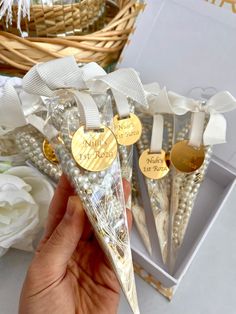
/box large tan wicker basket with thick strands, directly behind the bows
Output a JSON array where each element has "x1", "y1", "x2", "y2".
[{"x1": 0, "y1": 0, "x2": 143, "y2": 76}]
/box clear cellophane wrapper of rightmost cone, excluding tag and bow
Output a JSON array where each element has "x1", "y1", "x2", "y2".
[{"x1": 168, "y1": 113, "x2": 212, "y2": 273}]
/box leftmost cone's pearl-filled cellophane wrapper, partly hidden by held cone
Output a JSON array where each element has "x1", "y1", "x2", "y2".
[{"x1": 14, "y1": 124, "x2": 62, "y2": 182}]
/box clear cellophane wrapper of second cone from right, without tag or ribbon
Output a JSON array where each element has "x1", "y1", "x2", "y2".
[{"x1": 137, "y1": 113, "x2": 173, "y2": 263}]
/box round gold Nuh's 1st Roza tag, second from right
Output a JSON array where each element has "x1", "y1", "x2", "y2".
[{"x1": 139, "y1": 149, "x2": 169, "y2": 179}]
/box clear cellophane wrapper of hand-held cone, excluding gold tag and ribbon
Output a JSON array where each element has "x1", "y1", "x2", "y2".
[{"x1": 46, "y1": 91, "x2": 139, "y2": 313}]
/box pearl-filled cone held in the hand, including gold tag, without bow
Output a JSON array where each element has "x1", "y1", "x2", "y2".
[{"x1": 45, "y1": 91, "x2": 139, "y2": 313}]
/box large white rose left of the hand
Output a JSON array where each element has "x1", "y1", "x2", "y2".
[{"x1": 0, "y1": 166, "x2": 54, "y2": 256}]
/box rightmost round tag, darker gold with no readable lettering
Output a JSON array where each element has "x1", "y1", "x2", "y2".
[{"x1": 170, "y1": 140, "x2": 205, "y2": 173}]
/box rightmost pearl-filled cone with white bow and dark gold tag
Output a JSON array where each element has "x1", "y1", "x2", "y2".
[{"x1": 168, "y1": 89, "x2": 236, "y2": 273}]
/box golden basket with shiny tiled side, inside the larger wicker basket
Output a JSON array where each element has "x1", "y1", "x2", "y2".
[{"x1": 0, "y1": 0, "x2": 106, "y2": 37}]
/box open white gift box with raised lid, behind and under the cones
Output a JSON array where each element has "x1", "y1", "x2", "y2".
[{"x1": 119, "y1": 0, "x2": 236, "y2": 299}]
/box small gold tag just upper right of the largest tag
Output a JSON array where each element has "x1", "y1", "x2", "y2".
[{"x1": 113, "y1": 113, "x2": 142, "y2": 146}]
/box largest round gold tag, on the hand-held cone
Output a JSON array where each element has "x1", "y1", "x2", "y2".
[{"x1": 71, "y1": 125, "x2": 118, "y2": 171}]
